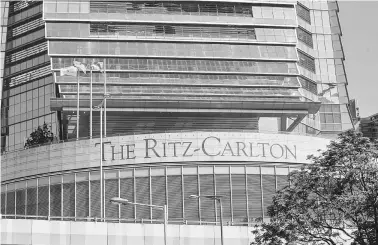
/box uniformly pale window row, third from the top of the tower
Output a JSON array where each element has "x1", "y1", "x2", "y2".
[{"x1": 49, "y1": 41, "x2": 297, "y2": 59}]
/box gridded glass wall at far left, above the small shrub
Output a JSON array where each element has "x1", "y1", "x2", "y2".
[{"x1": 1, "y1": 1, "x2": 59, "y2": 152}]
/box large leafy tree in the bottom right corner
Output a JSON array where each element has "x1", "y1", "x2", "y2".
[{"x1": 252, "y1": 130, "x2": 378, "y2": 245}]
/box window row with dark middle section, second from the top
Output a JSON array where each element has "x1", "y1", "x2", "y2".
[{"x1": 46, "y1": 22, "x2": 297, "y2": 43}]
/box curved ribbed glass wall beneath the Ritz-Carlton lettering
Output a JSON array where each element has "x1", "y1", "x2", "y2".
[{"x1": 2, "y1": 165, "x2": 290, "y2": 224}]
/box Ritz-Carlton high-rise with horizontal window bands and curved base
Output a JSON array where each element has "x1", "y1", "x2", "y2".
[{"x1": 0, "y1": 0, "x2": 353, "y2": 244}]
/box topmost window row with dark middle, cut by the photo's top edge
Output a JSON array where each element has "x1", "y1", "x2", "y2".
[{"x1": 44, "y1": 0, "x2": 296, "y2": 20}]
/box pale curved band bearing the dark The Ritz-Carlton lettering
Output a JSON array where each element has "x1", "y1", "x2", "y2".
[{"x1": 96, "y1": 132, "x2": 326, "y2": 164}]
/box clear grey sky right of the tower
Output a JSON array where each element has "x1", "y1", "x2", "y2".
[{"x1": 338, "y1": 0, "x2": 378, "y2": 117}]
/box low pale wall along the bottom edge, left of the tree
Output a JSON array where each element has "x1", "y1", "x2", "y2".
[{"x1": 0, "y1": 219, "x2": 252, "y2": 245}]
